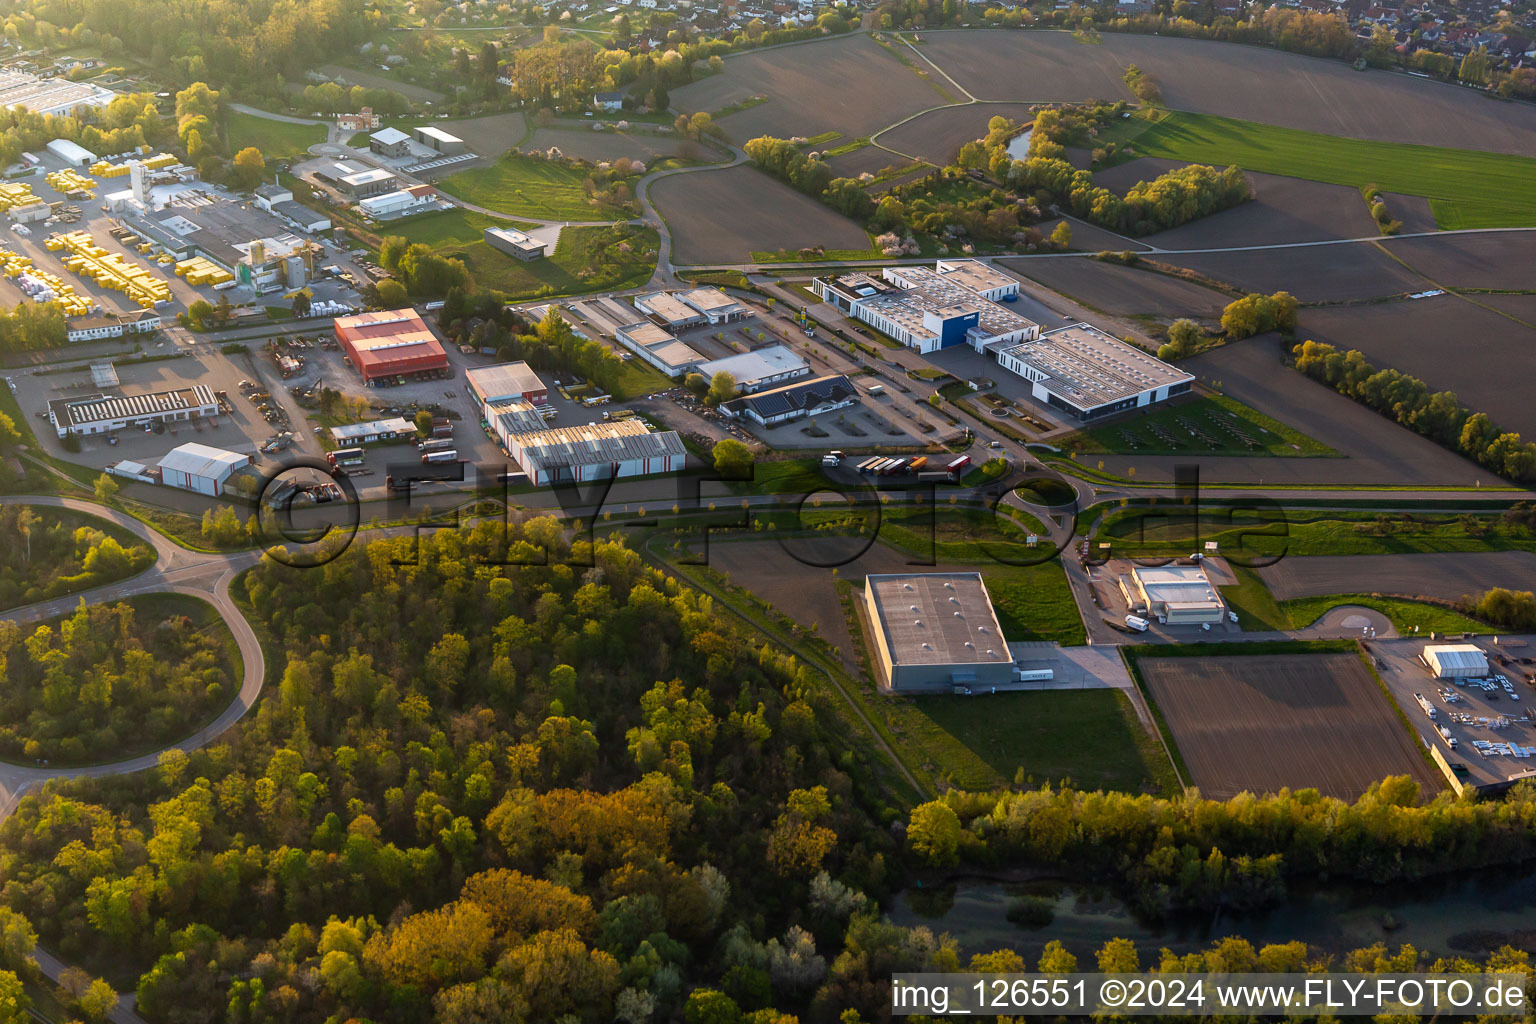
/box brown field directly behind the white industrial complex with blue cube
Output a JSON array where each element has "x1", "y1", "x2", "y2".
[{"x1": 998, "y1": 254, "x2": 1232, "y2": 319}]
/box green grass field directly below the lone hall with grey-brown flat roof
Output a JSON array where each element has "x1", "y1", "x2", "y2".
[{"x1": 903, "y1": 689, "x2": 1177, "y2": 792}]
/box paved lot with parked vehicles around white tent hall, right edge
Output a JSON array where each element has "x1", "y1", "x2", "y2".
[{"x1": 1367, "y1": 637, "x2": 1536, "y2": 788}]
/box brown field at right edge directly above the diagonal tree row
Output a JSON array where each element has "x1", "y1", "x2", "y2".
[{"x1": 1299, "y1": 295, "x2": 1536, "y2": 438}]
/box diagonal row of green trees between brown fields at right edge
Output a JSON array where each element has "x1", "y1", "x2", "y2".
[{"x1": 1292, "y1": 341, "x2": 1536, "y2": 484}]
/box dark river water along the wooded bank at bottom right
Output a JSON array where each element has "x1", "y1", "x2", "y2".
[{"x1": 888, "y1": 864, "x2": 1536, "y2": 964}]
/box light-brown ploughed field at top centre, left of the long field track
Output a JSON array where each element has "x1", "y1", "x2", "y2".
[{"x1": 671, "y1": 34, "x2": 946, "y2": 144}]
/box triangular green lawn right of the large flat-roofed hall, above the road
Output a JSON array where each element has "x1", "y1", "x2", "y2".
[{"x1": 1063, "y1": 395, "x2": 1338, "y2": 457}]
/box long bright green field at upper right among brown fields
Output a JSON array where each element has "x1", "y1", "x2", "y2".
[{"x1": 1098, "y1": 111, "x2": 1536, "y2": 229}]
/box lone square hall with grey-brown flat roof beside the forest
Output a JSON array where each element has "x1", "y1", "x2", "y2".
[{"x1": 865, "y1": 573, "x2": 1014, "y2": 692}]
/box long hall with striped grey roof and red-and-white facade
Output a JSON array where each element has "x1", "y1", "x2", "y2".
[{"x1": 502, "y1": 419, "x2": 688, "y2": 485}]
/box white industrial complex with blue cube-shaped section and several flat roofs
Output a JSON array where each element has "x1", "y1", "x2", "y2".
[{"x1": 811, "y1": 261, "x2": 1040, "y2": 355}]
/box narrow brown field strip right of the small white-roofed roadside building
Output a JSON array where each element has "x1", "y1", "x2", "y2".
[{"x1": 1258, "y1": 551, "x2": 1536, "y2": 602}]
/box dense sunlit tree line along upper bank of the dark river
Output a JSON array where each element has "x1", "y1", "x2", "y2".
[{"x1": 906, "y1": 777, "x2": 1536, "y2": 917}]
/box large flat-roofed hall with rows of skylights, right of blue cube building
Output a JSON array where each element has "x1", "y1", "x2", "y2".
[{"x1": 994, "y1": 324, "x2": 1195, "y2": 421}]
